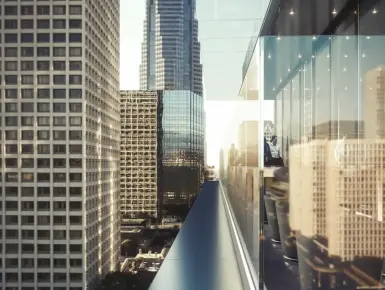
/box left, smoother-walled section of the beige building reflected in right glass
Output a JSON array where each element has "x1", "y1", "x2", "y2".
[{"x1": 289, "y1": 140, "x2": 327, "y2": 237}]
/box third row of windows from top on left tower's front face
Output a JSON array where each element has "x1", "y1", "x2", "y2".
[{"x1": 0, "y1": 33, "x2": 82, "y2": 43}]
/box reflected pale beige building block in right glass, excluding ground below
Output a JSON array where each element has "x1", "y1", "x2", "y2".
[{"x1": 290, "y1": 139, "x2": 385, "y2": 261}]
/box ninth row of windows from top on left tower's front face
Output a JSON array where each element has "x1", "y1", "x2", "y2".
[{"x1": 0, "y1": 116, "x2": 82, "y2": 127}]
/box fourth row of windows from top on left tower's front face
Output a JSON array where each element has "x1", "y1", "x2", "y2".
[{"x1": 0, "y1": 46, "x2": 83, "y2": 57}]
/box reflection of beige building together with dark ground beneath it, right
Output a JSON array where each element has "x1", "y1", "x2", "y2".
[{"x1": 290, "y1": 139, "x2": 385, "y2": 289}]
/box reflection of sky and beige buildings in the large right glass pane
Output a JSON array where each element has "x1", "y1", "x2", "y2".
[{"x1": 260, "y1": 35, "x2": 385, "y2": 290}]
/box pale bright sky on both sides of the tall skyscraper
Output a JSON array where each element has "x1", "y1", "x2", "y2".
[{"x1": 120, "y1": 0, "x2": 268, "y2": 163}]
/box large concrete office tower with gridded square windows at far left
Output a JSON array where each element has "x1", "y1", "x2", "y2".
[{"x1": 0, "y1": 0, "x2": 120, "y2": 290}]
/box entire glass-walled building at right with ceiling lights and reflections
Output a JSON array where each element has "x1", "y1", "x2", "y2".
[{"x1": 226, "y1": 0, "x2": 385, "y2": 290}]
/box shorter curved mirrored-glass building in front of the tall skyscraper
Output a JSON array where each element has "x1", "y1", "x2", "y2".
[{"x1": 161, "y1": 91, "x2": 204, "y2": 206}]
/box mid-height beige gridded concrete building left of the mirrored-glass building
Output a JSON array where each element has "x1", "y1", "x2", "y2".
[{"x1": 120, "y1": 91, "x2": 161, "y2": 218}]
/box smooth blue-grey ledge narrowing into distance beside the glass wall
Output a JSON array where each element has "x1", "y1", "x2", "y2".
[{"x1": 149, "y1": 181, "x2": 243, "y2": 290}]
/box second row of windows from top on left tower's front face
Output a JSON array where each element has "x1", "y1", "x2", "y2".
[{"x1": 0, "y1": 19, "x2": 82, "y2": 29}]
